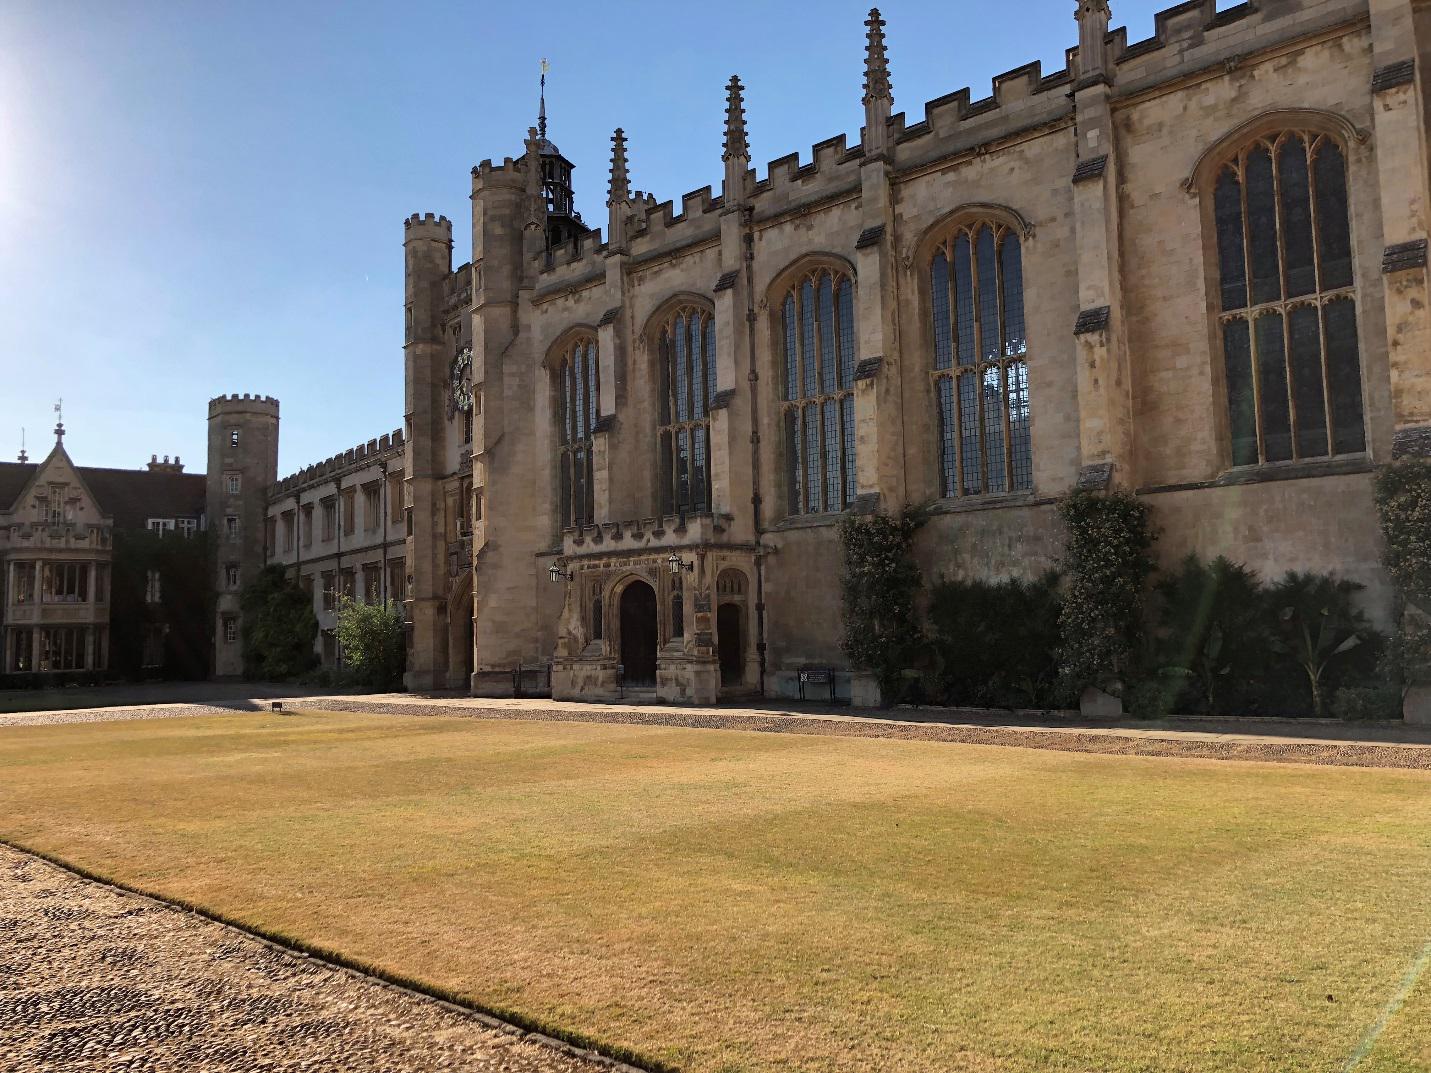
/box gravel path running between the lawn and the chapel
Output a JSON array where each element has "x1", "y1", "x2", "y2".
[{"x1": 0, "y1": 694, "x2": 1431, "y2": 770}]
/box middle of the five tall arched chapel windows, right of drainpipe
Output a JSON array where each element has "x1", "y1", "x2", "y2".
[{"x1": 780, "y1": 268, "x2": 854, "y2": 514}]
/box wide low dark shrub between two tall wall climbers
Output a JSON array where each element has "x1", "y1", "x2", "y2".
[{"x1": 929, "y1": 571, "x2": 1068, "y2": 708}]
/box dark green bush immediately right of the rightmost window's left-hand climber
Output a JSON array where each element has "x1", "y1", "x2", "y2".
[{"x1": 1148, "y1": 555, "x2": 1269, "y2": 714}]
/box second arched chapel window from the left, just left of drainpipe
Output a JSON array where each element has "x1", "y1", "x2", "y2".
[{"x1": 657, "y1": 306, "x2": 716, "y2": 514}]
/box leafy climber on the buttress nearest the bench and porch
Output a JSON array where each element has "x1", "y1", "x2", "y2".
[{"x1": 840, "y1": 506, "x2": 927, "y2": 702}]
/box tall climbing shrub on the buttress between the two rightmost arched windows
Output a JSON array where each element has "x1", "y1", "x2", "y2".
[{"x1": 1059, "y1": 491, "x2": 1153, "y2": 691}]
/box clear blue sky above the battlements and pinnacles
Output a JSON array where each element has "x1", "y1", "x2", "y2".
[{"x1": 0, "y1": 0, "x2": 1171, "y2": 474}]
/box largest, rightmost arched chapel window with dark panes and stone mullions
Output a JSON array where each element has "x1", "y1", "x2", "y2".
[{"x1": 1212, "y1": 130, "x2": 1367, "y2": 465}]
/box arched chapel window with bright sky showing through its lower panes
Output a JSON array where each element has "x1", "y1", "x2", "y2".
[{"x1": 929, "y1": 220, "x2": 1033, "y2": 496}]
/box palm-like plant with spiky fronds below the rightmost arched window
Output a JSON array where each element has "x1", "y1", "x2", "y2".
[{"x1": 1266, "y1": 571, "x2": 1381, "y2": 717}]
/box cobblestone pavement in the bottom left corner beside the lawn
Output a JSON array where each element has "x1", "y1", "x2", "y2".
[{"x1": 0, "y1": 846, "x2": 615, "y2": 1073}]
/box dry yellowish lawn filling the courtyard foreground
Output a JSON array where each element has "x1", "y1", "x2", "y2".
[{"x1": 0, "y1": 712, "x2": 1431, "y2": 1073}]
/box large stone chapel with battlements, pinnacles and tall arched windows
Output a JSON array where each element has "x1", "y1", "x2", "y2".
[{"x1": 263, "y1": 0, "x2": 1431, "y2": 702}]
